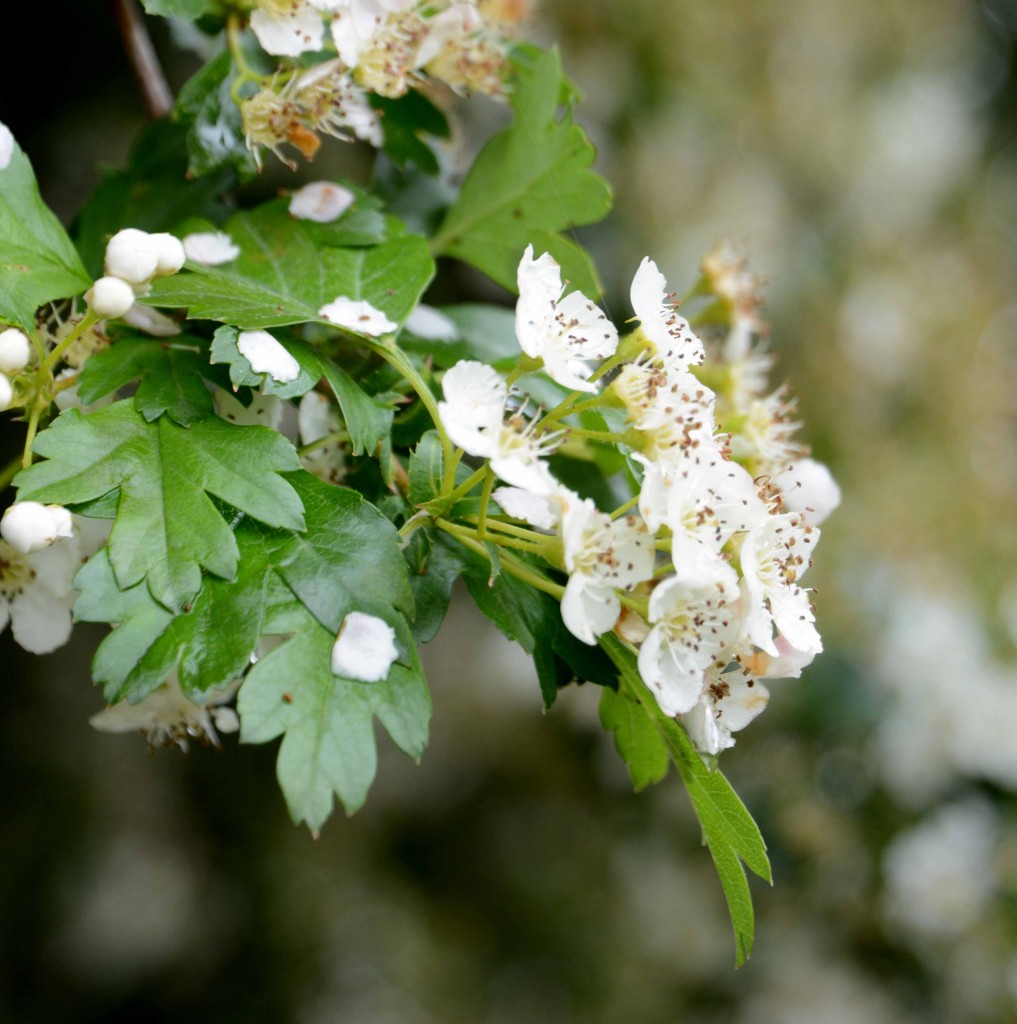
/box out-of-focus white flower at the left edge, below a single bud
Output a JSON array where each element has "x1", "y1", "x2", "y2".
[{"x1": 0, "y1": 516, "x2": 110, "y2": 654}]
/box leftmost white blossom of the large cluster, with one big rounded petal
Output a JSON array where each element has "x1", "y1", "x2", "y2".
[{"x1": 438, "y1": 359, "x2": 557, "y2": 495}]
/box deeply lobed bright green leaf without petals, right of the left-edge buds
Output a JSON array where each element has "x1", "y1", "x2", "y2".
[{"x1": 16, "y1": 401, "x2": 304, "y2": 610}]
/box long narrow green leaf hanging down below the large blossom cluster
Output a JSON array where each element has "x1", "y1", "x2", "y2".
[{"x1": 600, "y1": 633, "x2": 772, "y2": 967}]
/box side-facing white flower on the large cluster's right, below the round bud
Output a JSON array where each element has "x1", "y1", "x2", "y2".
[{"x1": 740, "y1": 513, "x2": 822, "y2": 655}]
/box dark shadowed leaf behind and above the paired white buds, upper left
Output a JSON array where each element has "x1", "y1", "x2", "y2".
[{"x1": 73, "y1": 121, "x2": 235, "y2": 278}]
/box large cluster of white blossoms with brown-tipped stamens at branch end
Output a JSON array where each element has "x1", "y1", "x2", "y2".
[{"x1": 439, "y1": 240, "x2": 839, "y2": 754}]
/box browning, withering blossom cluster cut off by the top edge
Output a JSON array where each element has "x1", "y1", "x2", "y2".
[{"x1": 242, "y1": 0, "x2": 512, "y2": 158}]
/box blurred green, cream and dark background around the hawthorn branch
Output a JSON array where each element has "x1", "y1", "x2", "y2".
[{"x1": 0, "y1": 0, "x2": 1017, "y2": 1024}]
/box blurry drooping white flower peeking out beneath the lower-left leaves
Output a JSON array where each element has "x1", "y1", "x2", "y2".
[{"x1": 88, "y1": 672, "x2": 240, "y2": 751}]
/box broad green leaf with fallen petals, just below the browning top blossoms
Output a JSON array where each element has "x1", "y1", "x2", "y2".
[{"x1": 144, "y1": 201, "x2": 434, "y2": 329}]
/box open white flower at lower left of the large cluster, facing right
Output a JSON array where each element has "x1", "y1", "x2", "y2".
[{"x1": 558, "y1": 488, "x2": 654, "y2": 644}]
